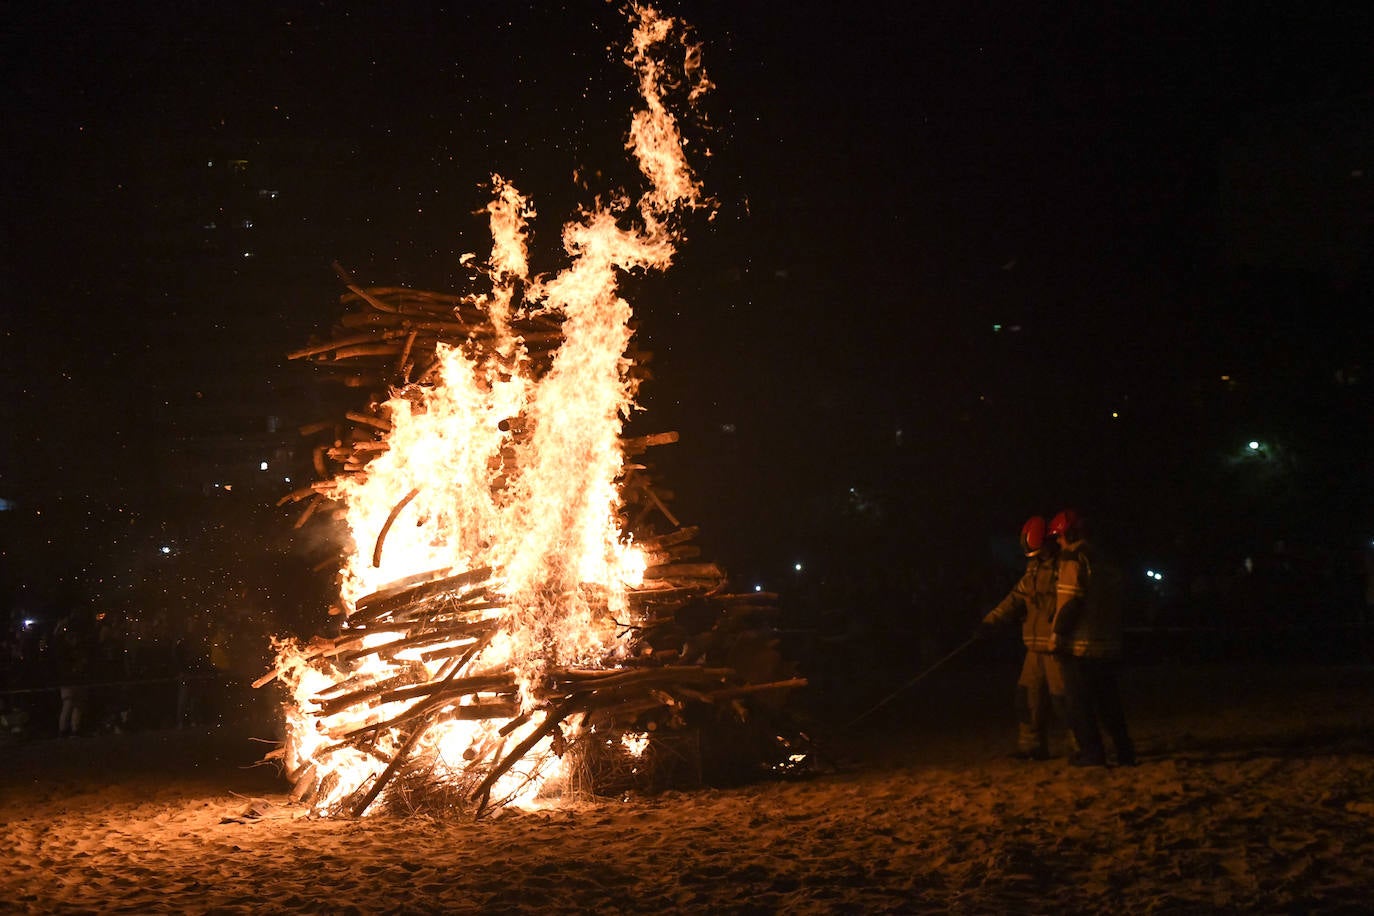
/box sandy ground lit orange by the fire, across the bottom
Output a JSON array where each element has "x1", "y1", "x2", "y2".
[{"x1": 0, "y1": 666, "x2": 1374, "y2": 913}]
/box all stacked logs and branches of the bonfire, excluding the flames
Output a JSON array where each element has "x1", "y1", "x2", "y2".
[{"x1": 254, "y1": 271, "x2": 805, "y2": 816}]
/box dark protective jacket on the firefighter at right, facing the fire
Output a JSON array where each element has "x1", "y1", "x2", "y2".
[{"x1": 1052, "y1": 540, "x2": 1121, "y2": 658}]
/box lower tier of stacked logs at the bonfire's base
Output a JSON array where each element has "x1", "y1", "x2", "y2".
[{"x1": 254, "y1": 569, "x2": 805, "y2": 816}]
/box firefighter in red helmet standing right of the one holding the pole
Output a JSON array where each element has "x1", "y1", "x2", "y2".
[{"x1": 1050, "y1": 509, "x2": 1136, "y2": 766}]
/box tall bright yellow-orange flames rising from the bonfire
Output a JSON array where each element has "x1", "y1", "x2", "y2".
[{"x1": 278, "y1": 5, "x2": 709, "y2": 812}]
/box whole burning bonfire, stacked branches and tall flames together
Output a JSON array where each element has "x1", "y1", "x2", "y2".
[{"x1": 257, "y1": 5, "x2": 804, "y2": 816}]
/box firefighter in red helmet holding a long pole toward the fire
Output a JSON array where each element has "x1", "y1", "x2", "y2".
[{"x1": 978, "y1": 515, "x2": 1065, "y2": 761}]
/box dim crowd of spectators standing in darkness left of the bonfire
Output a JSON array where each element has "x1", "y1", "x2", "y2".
[{"x1": 0, "y1": 608, "x2": 281, "y2": 739}]
